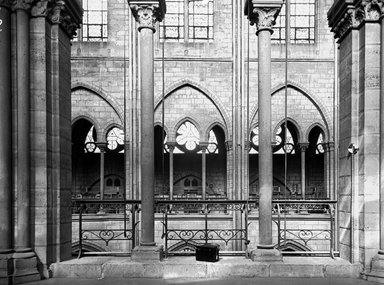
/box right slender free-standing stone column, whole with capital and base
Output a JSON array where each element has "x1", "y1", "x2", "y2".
[{"x1": 245, "y1": 0, "x2": 283, "y2": 261}]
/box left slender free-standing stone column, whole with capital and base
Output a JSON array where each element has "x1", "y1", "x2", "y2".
[{"x1": 128, "y1": 0, "x2": 165, "y2": 260}]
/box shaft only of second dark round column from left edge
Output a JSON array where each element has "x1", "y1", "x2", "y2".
[{"x1": 15, "y1": 9, "x2": 31, "y2": 251}]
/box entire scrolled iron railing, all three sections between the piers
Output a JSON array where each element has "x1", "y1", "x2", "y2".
[{"x1": 73, "y1": 199, "x2": 337, "y2": 258}]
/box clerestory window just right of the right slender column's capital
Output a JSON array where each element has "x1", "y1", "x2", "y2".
[{"x1": 271, "y1": 0, "x2": 316, "y2": 44}]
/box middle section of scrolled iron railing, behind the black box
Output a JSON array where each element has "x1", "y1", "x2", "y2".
[{"x1": 156, "y1": 200, "x2": 257, "y2": 257}]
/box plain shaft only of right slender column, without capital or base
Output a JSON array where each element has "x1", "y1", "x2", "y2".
[{"x1": 257, "y1": 29, "x2": 273, "y2": 245}]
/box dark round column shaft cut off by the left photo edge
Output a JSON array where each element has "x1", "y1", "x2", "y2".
[{"x1": 0, "y1": 4, "x2": 12, "y2": 254}]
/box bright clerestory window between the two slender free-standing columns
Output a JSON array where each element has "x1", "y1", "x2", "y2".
[{"x1": 160, "y1": 0, "x2": 213, "y2": 41}]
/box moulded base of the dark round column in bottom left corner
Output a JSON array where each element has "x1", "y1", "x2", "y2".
[{"x1": 12, "y1": 248, "x2": 41, "y2": 284}]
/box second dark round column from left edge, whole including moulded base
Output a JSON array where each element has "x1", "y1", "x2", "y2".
[{"x1": 12, "y1": 0, "x2": 40, "y2": 283}]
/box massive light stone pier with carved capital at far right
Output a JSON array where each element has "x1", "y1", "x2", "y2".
[{"x1": 328, "y1": 0, "x2": 383, "y2": 268}]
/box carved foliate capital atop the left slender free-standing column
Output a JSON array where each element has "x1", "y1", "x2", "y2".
[{"x1": 129, "y1": 1, "x2": 165, "y2": 32}]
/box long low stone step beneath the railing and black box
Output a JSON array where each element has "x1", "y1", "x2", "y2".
[{"x1": 50, "y1": 256, "x2": 362, "y2": 279}]
